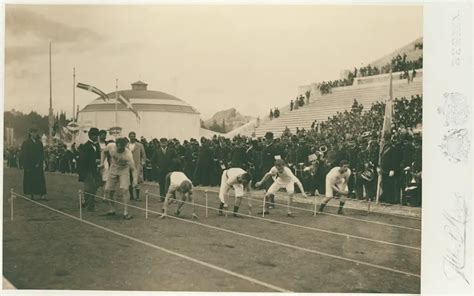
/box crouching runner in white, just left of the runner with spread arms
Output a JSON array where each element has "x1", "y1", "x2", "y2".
[{"x1": 219, "y1": 168, "x2": 252, "y2": 218}]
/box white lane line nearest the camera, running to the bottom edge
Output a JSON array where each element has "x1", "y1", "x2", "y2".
[{"x1": 14, "y1": 193, "x2": 292, "y2": 292}]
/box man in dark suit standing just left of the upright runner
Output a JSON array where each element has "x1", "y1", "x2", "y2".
[{"x1": 78, "y1": 127, "x2": 101, "y2": 212}]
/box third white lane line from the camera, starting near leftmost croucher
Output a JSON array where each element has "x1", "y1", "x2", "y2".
[{"x1": 144, "y1": 193, "x2": 421, "y2": 251}]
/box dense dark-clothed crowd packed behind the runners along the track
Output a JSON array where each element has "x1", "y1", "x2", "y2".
[{"x1": 5, "y1": 95, "x2": 422, "y2": 204}]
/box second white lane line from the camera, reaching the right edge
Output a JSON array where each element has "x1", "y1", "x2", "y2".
[{"x1": 79, "y1": 194, "x2": 420, "y2": 278}]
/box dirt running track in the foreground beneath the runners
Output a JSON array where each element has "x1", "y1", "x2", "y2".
[{"x1": 3, "y1": 168, "x2": 421, "y2": 293}]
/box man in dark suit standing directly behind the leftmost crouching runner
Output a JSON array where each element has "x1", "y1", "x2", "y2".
[{"x1": 151, "y1": 138, "x2": 176, "y2": 201}]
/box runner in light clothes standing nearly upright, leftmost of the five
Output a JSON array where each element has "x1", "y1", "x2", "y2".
[{"x1": 101, "y1": 138, "x2": 137, "y2": 220}]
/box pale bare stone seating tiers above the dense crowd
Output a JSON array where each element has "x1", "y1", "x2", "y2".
[{"x1": 244, "y1": 77, "x2": 423, "y2": 137}]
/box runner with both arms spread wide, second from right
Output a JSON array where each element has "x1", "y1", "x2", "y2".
[{"x1": 255, "y1": 159, "x2": 306, "y2": 217}]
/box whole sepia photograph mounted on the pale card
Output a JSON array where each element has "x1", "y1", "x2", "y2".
[{"x1": 2, "y1": 4, "x2": 456, "y2": 294}]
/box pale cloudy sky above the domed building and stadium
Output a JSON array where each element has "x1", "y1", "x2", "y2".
[{"x1": 5, "y1": 5, "x2": 423, "y2": 120}]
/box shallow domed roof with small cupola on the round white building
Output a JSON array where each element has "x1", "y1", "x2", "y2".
[{"x1": 81, "y1": 81, "x2": 199, "y2": 114}]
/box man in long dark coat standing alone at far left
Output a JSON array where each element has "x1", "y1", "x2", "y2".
[{"x1": 20, "y1": 128, "x2": 46, "y2": 200}]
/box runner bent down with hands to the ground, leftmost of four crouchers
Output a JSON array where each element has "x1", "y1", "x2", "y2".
[{"x1": 161, "y1": 172, "x2": 195, "y2": 218}]
